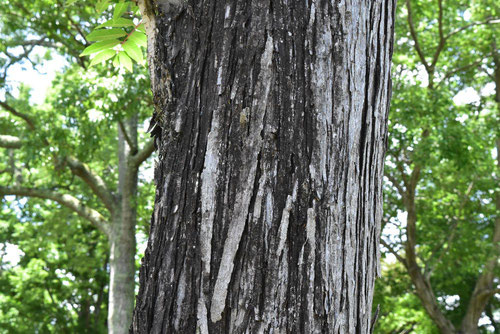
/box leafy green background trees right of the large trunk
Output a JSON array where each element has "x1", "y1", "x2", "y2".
[{"x1": 378, "y1": 1, "x2": 500, "y2": 333}]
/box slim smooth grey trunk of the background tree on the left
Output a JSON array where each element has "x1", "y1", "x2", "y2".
[{"x1": 108, "y1": 118, "x2": 137, "y2": 334}]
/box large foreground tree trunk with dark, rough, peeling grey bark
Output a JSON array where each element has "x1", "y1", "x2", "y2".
[{"x1": 131, "y1": 0, "x2": 395, "y2": 333}]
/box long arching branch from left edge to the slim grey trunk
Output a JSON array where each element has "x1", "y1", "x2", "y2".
[{"x1": 0, "y1": 186, "x2": 110, "y2": 237}]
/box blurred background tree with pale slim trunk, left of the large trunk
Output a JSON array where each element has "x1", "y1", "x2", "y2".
[{"x1": 0, "y1": 1, "x2": 153, "y2": 333}]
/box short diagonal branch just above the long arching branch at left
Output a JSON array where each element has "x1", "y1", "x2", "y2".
[{"x1": 65, "y1": 156, "x2": 115, "y2": 212}]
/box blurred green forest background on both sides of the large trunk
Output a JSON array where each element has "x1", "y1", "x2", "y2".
[{"x1": 0, "y1": 0, "x2": 500, "y2": 333}]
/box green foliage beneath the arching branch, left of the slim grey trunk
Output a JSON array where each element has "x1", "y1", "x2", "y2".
[{"x1": 0, "y1": 200, "x2": 108, "y2": 334}]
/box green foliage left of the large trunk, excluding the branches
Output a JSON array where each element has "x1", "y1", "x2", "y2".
[{"x1": 0, "y1": 0, "x2": 154, "y2": 333}]
